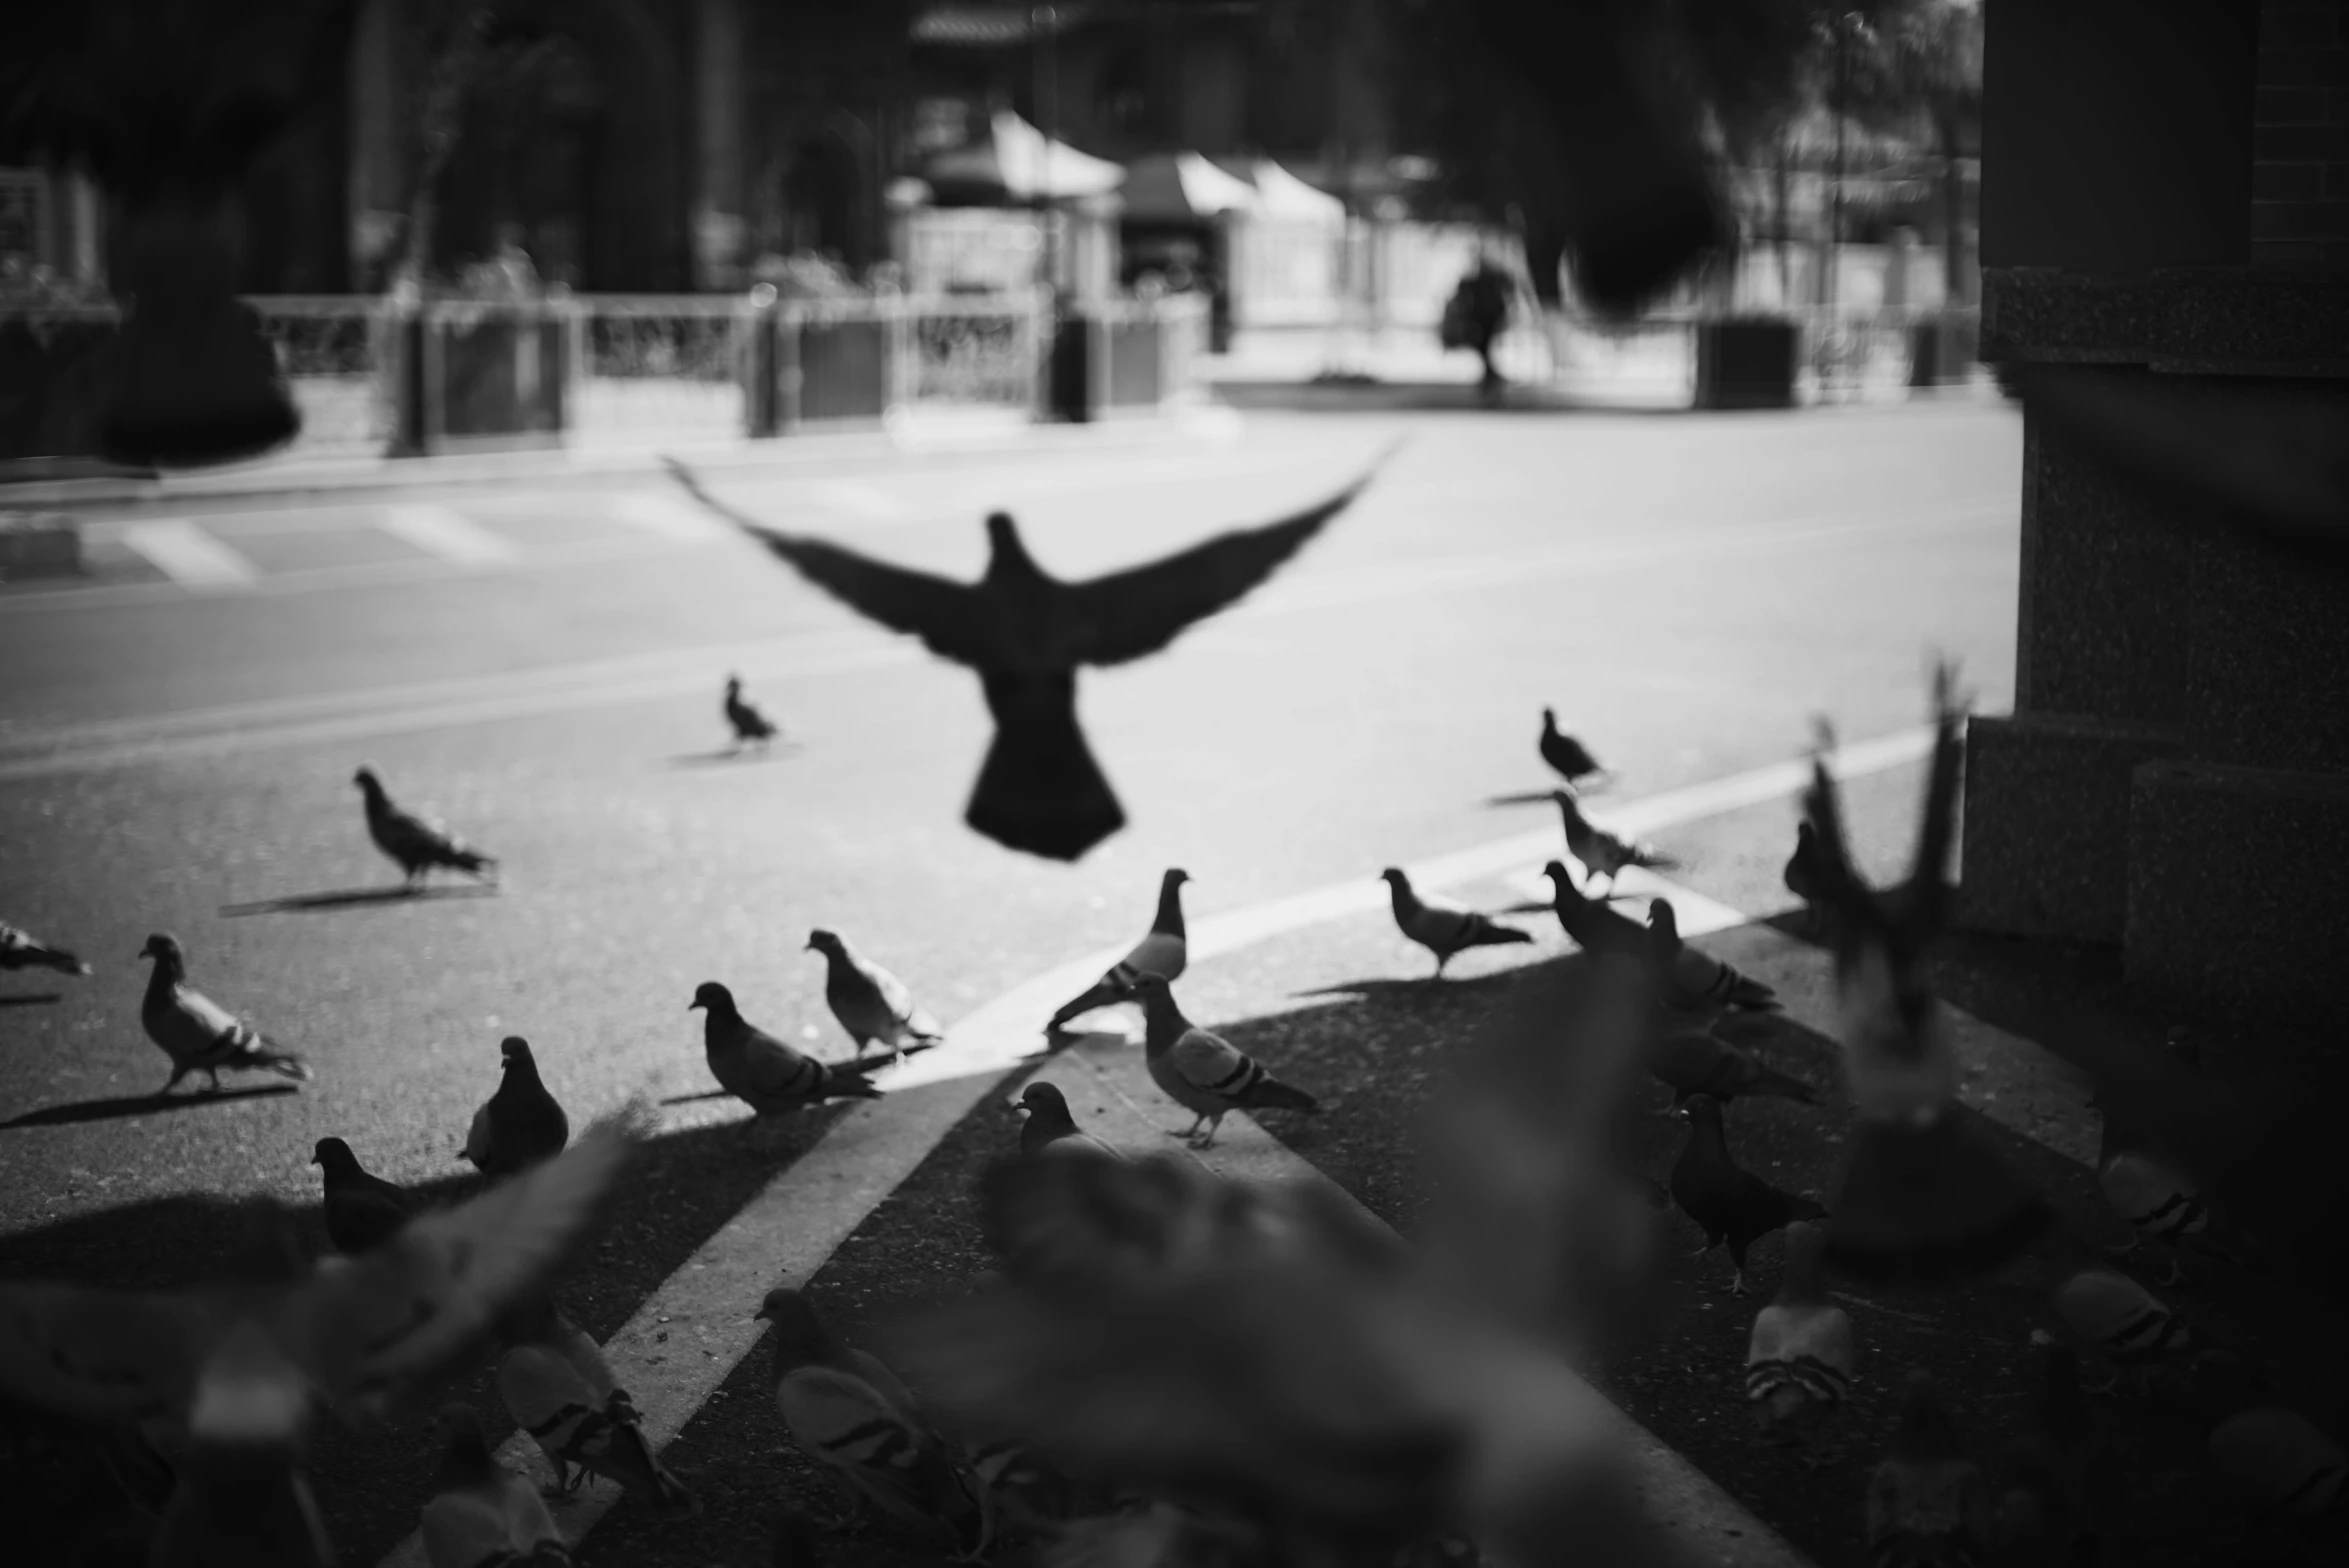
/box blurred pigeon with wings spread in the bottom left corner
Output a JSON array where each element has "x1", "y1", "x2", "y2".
[{"x1": 0, "y1": 1108, "x2": 644, "y2": 1563}]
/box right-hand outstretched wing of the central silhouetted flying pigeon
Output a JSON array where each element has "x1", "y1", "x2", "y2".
[{"x1": 1066, "y1": 439, "x2": 1402, "y2": 664}]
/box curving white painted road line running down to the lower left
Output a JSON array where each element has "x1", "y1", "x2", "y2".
[{"x1": 383, "y1": 730, "x2": 1929, "y2": 1568}]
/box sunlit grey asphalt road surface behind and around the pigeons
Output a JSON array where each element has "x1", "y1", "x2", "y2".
[{"x1": 0, "y1": 394, "x2": 2189, "y2": 1566}]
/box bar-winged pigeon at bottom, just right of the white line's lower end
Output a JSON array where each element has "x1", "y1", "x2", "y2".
[{"x1": 759, "y1": 1289, "x2": 991, "y2": 1563}]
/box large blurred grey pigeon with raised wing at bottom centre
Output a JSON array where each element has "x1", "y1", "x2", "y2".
[{"x1": 897, "y1": 957, "x2": 1691, "y2": 1568}]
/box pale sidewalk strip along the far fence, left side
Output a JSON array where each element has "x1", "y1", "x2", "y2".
[{"x1": 0, "y1": 399, "x2": 1243, "y2": 512}]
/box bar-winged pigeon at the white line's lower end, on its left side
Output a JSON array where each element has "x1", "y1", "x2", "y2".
[{"x1": 498, "y1": 1293, "x2": 698, "y2": 1514}]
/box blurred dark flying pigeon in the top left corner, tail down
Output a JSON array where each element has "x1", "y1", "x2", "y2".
[{"x1": 0, "y1": 0, "x2": 357, "y2": 465}]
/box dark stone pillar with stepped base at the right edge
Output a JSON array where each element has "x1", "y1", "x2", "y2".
[{"x1": 1961, "y1": 0, "x2": 2349, "y2": 1021}]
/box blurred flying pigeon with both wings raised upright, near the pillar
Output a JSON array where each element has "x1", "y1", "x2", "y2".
[{"x1": 1804, "y1": 662, "x2": 2053, "y2": 1282}]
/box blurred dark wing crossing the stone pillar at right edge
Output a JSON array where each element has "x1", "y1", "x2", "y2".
[{"x1": 2018, "y1": 366, "x2": 2349, "y2": 570}]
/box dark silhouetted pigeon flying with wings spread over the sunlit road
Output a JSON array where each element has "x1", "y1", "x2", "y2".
[{"x1": 669, "y1": 446, "x2": 1393, "y2": 861}]
